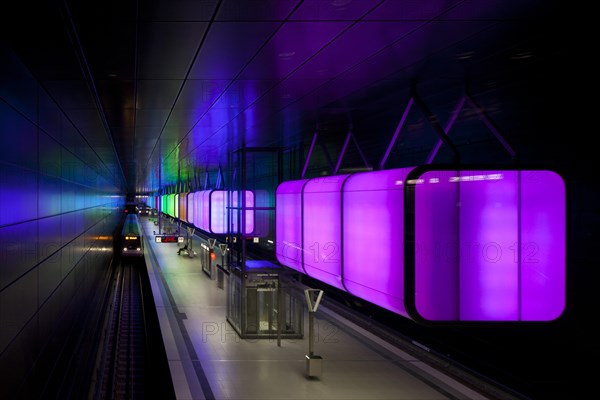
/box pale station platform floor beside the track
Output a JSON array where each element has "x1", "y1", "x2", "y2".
[{"x1": 142, "y1": 218, "x2": 486, "y2": 400}]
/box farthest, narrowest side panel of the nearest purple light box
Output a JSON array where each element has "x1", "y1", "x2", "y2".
[{"x1": 275, "y1": 179, "x2": 308, "y2": 272}]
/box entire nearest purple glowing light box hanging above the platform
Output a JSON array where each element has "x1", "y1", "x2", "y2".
[{"x1": 276, "y1": 166, "x2": 566, "y2": 323}]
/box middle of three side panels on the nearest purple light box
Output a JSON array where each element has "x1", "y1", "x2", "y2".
[{"x1": 302, "y1": 175, "x2": 348, "y2": 289}]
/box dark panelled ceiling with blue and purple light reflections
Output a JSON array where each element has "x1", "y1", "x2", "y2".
[{"x1": 3, "y1": 0, "x2": 555, "y2": 193}]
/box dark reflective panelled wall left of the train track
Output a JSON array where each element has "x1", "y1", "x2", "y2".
[{"x1": 0, "y1": 45, "x2": 123, "y2": 398}]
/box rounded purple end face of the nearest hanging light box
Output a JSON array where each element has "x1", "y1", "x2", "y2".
[{"x1": 414, "y1": 170, "x2": 566, "y2": 321}]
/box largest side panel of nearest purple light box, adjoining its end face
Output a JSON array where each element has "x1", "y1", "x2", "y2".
[{"x1": 342, "y1": 168, "x2": 413, "y2": 316}]
